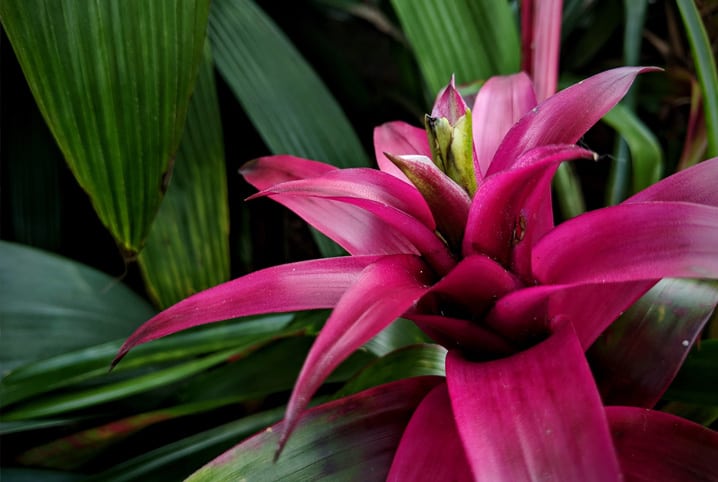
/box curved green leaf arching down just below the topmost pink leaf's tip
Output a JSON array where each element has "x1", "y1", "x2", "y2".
[{"x1": 603, "y1": 104, "x2": 664, "y2": 199}]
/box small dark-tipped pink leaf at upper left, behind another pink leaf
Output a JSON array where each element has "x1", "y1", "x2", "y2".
[{"x1": 239, "y1": 155, "x2": 338, "y2": 190}]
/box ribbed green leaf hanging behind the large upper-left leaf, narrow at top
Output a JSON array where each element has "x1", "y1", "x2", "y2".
[{"x1": 139, "y1": 39, "x2": 229, "y2": 308}]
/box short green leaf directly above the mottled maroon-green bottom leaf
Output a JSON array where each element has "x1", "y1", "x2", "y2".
[{"x1": 336, "y1": 344, "x2": 446, "y2": 397}]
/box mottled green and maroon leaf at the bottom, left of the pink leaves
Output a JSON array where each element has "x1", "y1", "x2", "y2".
[{"x1": 187, "y1": 377, "x2": 441, "y2": 482}]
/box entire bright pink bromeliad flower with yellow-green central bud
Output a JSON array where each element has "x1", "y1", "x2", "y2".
[{"x1": 118, "y1": 67, "x2": 718, "y2": 481}]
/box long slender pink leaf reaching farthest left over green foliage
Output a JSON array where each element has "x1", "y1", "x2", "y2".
[{"x1": 113, "y1": 256, "x2": 379, "y2": 365}]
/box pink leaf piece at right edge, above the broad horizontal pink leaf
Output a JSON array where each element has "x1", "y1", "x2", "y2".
[{"x1": 624, "y1": 158, "x2": 718, "y2": 206}]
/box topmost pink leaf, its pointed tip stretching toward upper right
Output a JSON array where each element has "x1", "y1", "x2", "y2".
[{"x1": 488, "y1": 67, "x2": 656, "y2": 175}]
